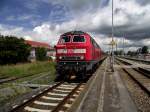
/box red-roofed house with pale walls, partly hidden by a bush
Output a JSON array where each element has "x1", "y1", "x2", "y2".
[{"x1": 25, "y1": 40, "x2": 56, "y2": 61}]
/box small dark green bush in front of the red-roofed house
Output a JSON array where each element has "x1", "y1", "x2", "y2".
[{"x1": 35, "y1": 47, "x2": 47, "y2": 61}]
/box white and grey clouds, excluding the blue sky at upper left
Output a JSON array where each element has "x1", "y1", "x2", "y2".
[{"x1": 0, "y1": 0, "x2": 150, "y2": 49}]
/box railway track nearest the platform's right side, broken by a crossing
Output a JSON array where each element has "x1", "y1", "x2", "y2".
[{"x1": 116, "y1": 59, "x2": 150, "y2": 96}]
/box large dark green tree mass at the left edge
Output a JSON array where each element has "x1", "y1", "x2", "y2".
[{"x1": 0, "y1": 35, "x2": 30, "y2": 64}]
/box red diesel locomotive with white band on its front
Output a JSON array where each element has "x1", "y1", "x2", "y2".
[{"x1": 55, "y1": 31, "x2": 102, "y2": 80}]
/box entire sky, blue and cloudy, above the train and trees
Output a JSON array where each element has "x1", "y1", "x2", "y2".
[{"x1": 0, "y1": 0, "x2": 150, "y2": 50}]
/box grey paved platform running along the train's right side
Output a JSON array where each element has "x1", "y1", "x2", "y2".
[{"x1": 76, "y1": 59, "x2": 137, "y2": 112}]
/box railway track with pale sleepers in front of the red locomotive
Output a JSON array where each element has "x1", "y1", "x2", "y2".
[{"x1": 10, "y1": 82, "x2": 85, "y2": 112}]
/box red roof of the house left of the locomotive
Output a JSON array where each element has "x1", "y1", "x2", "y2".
[{"x1": 25, "y1": 40, "x2": 52, "y2": 49}]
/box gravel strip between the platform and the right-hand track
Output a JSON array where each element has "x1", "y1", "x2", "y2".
[{"x1": 120, "y1": 70, "x2": 150, "y2": 112}]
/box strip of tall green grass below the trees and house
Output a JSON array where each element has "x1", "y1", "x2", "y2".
[{"x1": 0, "y1": 61, "x2": 55, "y2": 77}]
